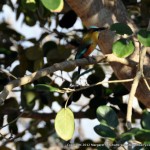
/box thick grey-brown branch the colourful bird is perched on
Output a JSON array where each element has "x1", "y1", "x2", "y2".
[{"x1": 0, "y1": 54, "x2": 136, "y2": 104}]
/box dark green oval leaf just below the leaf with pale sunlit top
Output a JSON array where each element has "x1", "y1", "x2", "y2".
[{"x1": 94, "y1": 124, "x2": 116, "y2": 138}]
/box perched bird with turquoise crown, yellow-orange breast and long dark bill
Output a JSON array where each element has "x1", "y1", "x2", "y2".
[{"x1": 75, "y1": 26, "x2": 106, "y2": 75}]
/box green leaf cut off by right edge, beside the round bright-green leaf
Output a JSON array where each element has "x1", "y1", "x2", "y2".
[{"x1": 137, "y1": 29, "x2": 150, "y2": 47}]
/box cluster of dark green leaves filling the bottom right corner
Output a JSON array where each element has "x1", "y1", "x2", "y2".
[{"x1": 94, "y1": 106, "x2": 150, "y2": 149}]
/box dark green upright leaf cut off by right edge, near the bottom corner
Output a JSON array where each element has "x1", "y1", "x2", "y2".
[{"x1": 141, "y1": 110, "x2": 150, "y2": 130}]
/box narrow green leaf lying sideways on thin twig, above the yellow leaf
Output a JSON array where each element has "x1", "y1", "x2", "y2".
[{"x1": 35, "y1": 84, "x2": 61, "y2": 92}]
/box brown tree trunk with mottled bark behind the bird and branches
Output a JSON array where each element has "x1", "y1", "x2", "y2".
[{"x1": 66, "y1": 0, "x2": 150, "y2": 107}]
